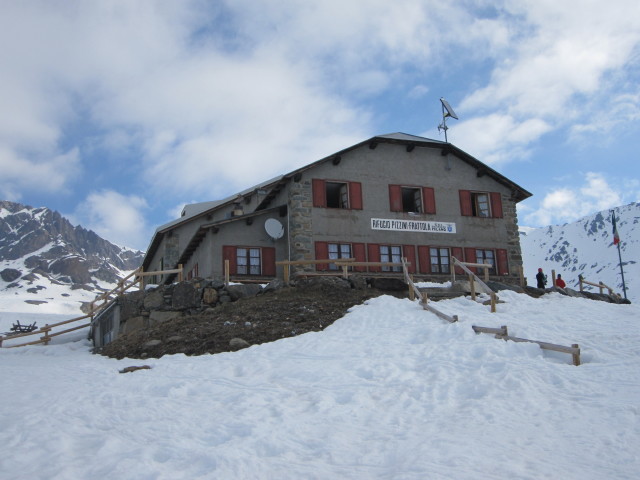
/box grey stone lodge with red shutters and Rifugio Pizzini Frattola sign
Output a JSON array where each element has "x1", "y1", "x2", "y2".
[{"x1": 143, "y1": 133, "x2": 531, "y2": 283}]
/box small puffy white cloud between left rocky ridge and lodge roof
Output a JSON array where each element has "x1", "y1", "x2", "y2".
[{"x1": 73, "y1": 190, "x2": 150, "y2": 249}]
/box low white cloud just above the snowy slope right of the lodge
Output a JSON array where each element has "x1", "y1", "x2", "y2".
[{"x1": 521, "y1": 172, "x2": 624, "y2": 226}]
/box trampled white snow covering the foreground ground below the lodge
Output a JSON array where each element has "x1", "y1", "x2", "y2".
[{"x1": 0, "y1": 291, "x2": 640, "y2": 480}]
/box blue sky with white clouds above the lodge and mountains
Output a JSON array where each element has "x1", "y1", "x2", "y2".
[{"x1": 0, "y1": 0, "x2": 640, "y2": 249}]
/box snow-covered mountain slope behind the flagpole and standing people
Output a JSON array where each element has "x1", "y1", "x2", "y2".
[{"x1": 520, "y1": 203, "x2": 640, "y2": 302}]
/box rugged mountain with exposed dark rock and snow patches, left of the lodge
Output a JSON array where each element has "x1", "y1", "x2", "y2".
[{"x1": 0, "y1": 201, "x2": 144, "y2": 313}]
